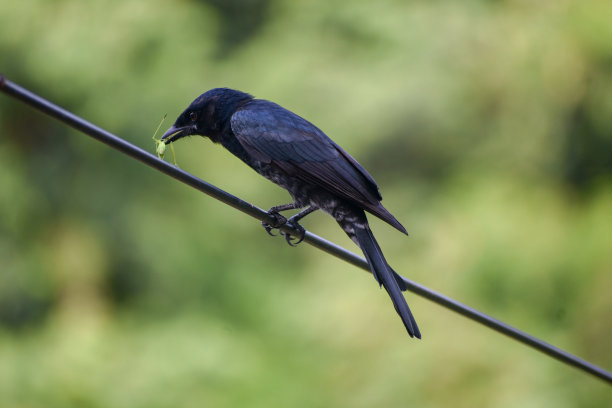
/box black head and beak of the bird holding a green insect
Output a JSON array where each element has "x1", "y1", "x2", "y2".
[{"x1": 162, "y1": 88, "x2": 253, "y2": 143}]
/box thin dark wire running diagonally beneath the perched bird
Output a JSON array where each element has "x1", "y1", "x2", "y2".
[{"x1": 0, "y1": 75, "x2": 612, "y2": 384}]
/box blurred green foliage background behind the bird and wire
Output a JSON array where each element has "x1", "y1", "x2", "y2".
[{"x1": 0, "y1": 0, "x2": 612, "y2": 408}]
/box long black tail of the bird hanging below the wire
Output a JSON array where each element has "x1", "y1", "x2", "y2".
[{"x1": 345, "y1": 218, "x2": 421, "y2": 339}]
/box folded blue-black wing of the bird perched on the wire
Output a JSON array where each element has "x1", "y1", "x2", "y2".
[{"x1": 231, "y1": 100, "x2": 381, "y2": 207}]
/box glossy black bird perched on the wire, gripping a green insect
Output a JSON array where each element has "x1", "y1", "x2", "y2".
[{"x1": 162, "y1": 88, "x2": 421, "y2": 338}]
